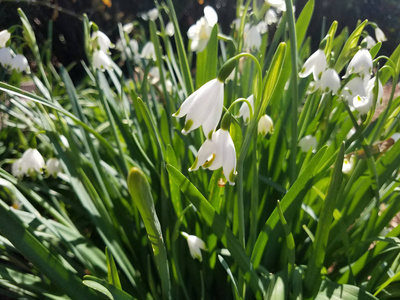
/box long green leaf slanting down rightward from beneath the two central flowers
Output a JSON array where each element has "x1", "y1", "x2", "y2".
[{"x1": 167, "y1": 165, "x2": 264, "y2": 294}]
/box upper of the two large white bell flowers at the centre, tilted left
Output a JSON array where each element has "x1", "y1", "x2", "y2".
[{"x1": 173, "y1": 78, "x2": 224, "y2": 139}]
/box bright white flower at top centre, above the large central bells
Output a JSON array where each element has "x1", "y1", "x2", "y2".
[{"x1": 187, "y1": 6, "x2": 218, "y2": 52}]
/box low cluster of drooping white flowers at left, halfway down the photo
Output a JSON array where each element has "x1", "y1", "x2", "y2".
[{"x1": 11, "y1": 148, "x2": 62, "y2": 178}]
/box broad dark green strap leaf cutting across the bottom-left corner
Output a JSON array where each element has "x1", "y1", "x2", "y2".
[{"x1": 0, "y1": 202, "x2": 96, "y2": 300}]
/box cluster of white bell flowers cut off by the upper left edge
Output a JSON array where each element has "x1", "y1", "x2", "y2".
[{"x1": 0, "y1": 29, "x2": 30, "y2": 74}]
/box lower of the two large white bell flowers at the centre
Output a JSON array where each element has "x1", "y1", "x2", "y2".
[{"x1": 189, "y1": 129, "x2": 237, "y2": 185}]
